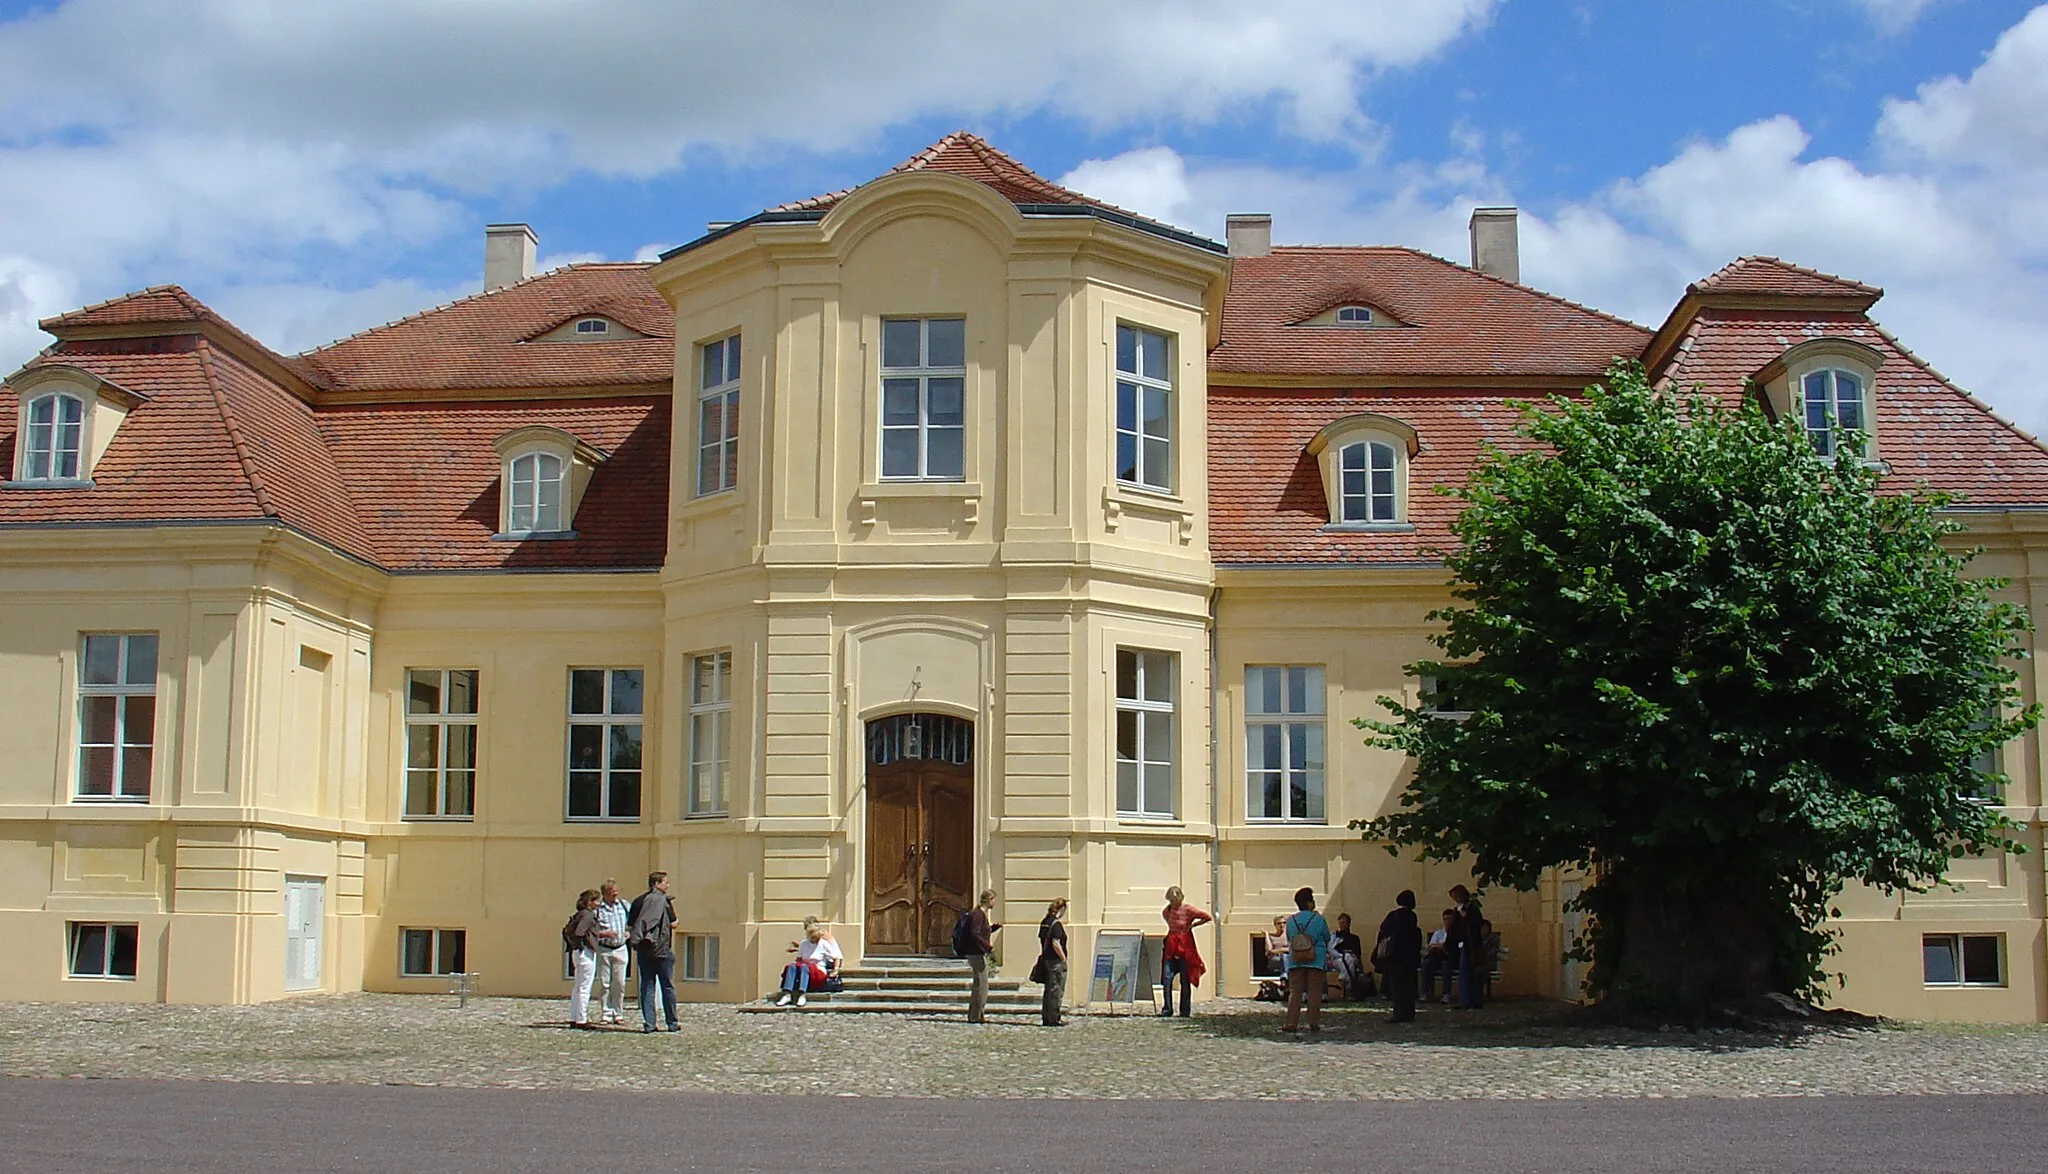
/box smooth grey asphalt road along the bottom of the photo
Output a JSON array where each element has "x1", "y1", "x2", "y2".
[{"x1": 0, "y1": 1080, "x2": 2048, "y2": 1174}]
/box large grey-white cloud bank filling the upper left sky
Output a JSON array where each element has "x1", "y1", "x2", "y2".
[{"x1": 0, "y1": 0, "x2": 1497, "y2": 369}]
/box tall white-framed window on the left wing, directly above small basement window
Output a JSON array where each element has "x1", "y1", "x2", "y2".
[{"x1": 78, "y1": 633, "x2": 156, "y2": 801}]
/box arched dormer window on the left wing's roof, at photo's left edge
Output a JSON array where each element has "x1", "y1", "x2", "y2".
[{"x1": 0, "y1": 363, "x2": 143, "y2": 490}]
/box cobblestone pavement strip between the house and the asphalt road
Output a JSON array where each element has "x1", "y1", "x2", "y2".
[{"x1": 0, "y1": 994, "x2": 2048, "y2": 1100}]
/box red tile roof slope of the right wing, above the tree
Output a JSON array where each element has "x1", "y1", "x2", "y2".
[{"x1": 1661, "y1": 307, "x2": 2048, "y2": 506}]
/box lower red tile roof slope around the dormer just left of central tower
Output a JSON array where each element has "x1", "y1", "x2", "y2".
[{"x1": 319, "y1": 395, "x2": 670, "y2": 572}]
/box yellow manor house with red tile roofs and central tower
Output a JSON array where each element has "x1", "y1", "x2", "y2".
[{"x1": 0, "y1": 133, "x2": 2048, "y2": 1020}]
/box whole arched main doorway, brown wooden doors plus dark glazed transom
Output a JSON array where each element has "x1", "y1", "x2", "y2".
[{"x1": 866, "y1": 713, "x2": 975, "y2": 955}]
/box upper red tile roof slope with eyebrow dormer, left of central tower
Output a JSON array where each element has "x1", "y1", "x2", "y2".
[{"x1": 299, "y1": 262, "x2": 676, "y2": 391}]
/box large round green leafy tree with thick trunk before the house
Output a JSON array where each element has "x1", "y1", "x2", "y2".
[{"x1": 1354, "y1": 365, "x2": 2038, "y2": 1018}]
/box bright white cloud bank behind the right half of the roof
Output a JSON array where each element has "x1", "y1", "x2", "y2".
[{"x1": 1065, "y1": 6, "x2": 2048, "y2": 434}]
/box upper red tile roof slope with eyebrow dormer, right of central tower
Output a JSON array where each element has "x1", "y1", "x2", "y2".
[{"x1": 1208, "y1": 246, "x2": 1651, "y2": 379}]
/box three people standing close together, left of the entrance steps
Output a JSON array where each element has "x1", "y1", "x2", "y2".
[{"x1": 561, "y1": 873, "x2": 682, "y2": 1033}]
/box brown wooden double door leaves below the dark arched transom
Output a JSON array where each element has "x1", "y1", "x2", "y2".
[{"x1": 866, "y1": 758, "x2": 975, "y2": 955}]
